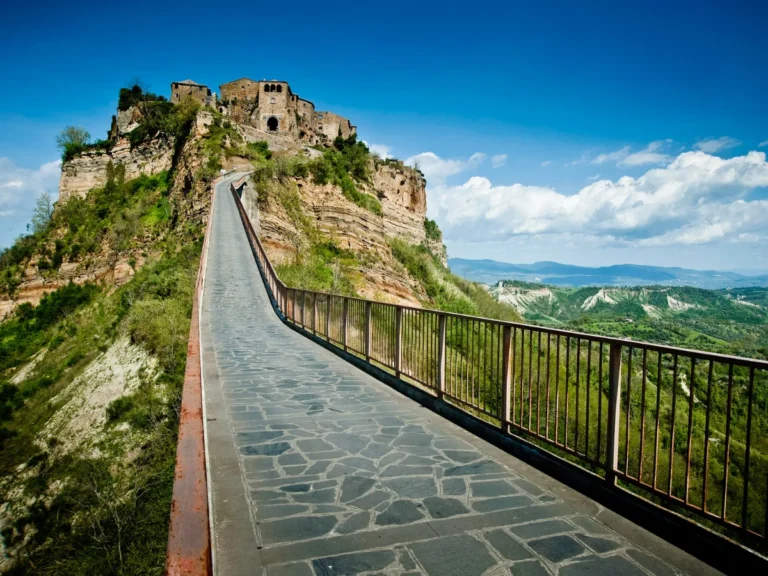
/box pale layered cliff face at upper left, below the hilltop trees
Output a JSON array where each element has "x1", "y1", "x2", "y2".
[{"x1": 59, "y1": 137, "x2": 173, "y2": 203}]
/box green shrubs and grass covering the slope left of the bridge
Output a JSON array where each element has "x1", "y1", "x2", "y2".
[{"x1": 0, "y1": 165, "x2": 202, "y2": 575}]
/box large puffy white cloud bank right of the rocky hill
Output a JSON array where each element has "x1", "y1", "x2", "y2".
[{"x1": 428, "y1": 151, "x2": 768, "y2": 246}]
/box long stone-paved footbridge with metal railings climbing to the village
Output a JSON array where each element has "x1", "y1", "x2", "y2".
[{"x1": 168, "y1": 175, "x2": 768, "y2": 576}]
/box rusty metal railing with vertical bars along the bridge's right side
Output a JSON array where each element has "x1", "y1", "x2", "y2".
[{"x1": 233, "y1": 182, "x2": 768, "y2": 549}]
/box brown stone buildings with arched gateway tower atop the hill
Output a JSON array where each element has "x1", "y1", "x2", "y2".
[{"x1": 219, "y1": 78, "x2": 356, "y2": 144}]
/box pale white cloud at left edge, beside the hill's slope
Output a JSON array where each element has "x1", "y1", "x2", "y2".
[{"x1": 0, "y1": 158, "x2": 61, "y2": 246}]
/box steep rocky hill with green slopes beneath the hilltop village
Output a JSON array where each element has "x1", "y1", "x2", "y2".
[{"x1": 0, "y1": 83, "x2": 519, "y2": 575}]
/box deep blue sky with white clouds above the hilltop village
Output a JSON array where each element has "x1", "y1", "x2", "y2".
[{"x1": 0, "y1": 0, "x2": 768, "y2": 270}]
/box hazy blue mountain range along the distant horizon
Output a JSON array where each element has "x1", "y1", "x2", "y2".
[{"x1": 448, "y1": 258, "x2": 768, "y2": 290}]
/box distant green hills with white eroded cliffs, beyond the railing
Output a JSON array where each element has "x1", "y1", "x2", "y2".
[{"x1": 489, "y1": 281, "x2": 768, "y2": 358}]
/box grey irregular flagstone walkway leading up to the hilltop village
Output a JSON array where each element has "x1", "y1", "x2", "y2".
[{"x1": 202, "y1": 178, "x2": 711, "y2": 576}]
